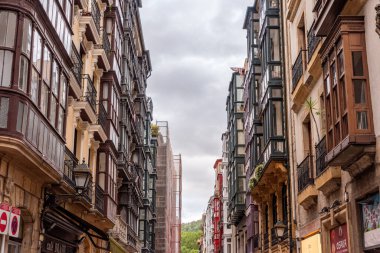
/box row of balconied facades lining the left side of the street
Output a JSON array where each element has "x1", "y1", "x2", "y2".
[{"x1": 0, "y1": 0, "x2": 156, "y2": 253}]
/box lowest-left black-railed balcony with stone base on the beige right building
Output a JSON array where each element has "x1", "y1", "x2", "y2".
[{"x1": 297, "y1": 155, "x2": 318, "y2": 209}]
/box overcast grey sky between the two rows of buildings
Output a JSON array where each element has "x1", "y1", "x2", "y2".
[{"x1": 140, "y1": 0, "x2": 249, "y2": 222}]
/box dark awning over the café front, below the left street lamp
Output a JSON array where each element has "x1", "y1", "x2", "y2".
[{"x1": 44, "y1": 200, "x2": 110, "y2": 251}]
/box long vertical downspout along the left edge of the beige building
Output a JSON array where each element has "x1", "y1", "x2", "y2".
[{"x1": 280, "y1": 1, "x2": 294, "y2": 253}]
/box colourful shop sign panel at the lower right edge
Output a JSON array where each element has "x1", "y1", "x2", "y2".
[{"x1": 359, "y1": 194, "x2": 380, "y2": 248}]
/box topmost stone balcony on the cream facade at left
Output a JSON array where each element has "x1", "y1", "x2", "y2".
[{"x1": 79, "y1": 0, "x2": 101, "y2": 44}]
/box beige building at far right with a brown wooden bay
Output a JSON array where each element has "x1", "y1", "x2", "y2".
[{"x1": 283, "y1": 0, "x2": 380, "y2": 253}]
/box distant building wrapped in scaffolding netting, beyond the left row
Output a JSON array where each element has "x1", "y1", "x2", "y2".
[{"x1": 155, "y1": 121, "x2": 182, "y2": 253}]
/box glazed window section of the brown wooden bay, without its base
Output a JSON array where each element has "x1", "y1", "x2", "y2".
[{"x1": 322, "y1": 21, "x2": 373, "y2": 151}]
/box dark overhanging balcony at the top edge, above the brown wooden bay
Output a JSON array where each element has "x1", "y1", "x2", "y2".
[{"x1": 313, "y1": 0, "x2": 347, "y2": 36}]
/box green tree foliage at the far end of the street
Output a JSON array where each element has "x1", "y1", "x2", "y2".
[{"x1": 181, "y1": 220, "x2": 203, "y2": 253}]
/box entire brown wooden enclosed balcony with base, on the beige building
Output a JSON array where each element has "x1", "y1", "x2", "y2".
[{"x1": 320, "y1": 16, "x2": 376, "y2": 177}]
